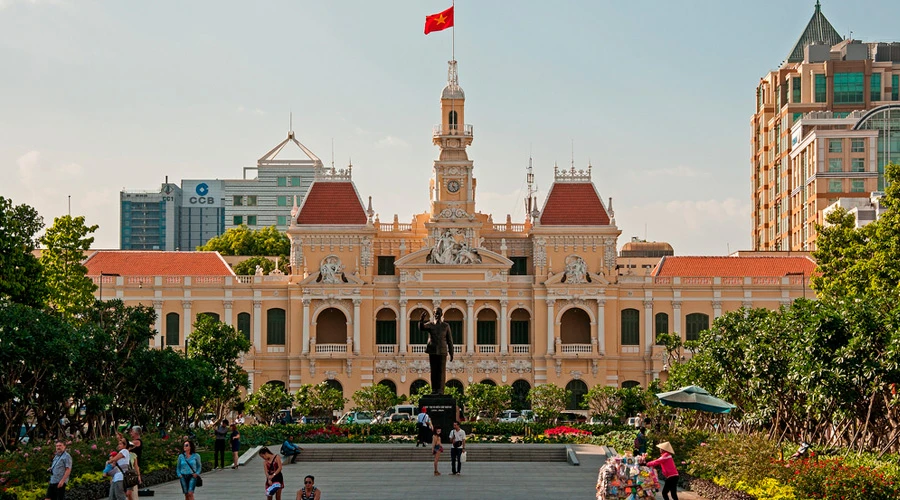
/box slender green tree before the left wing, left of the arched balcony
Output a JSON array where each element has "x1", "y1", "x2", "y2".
[{"x1": 188, "y1": 314, "x2": 250, "y2": 419}]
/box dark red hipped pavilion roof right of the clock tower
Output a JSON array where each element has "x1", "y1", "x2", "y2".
[{"x1": 541, "y1": 182, "x2": 609, "y2": 226}]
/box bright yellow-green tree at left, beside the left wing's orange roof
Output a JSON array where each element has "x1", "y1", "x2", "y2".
[{"x1": 40, "y1": 215, "x2": 99, "y2": 318}]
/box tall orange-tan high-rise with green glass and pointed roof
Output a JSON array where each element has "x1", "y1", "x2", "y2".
[{"x1": 750, "y1": 2, "x2": 900, "y2": 250}]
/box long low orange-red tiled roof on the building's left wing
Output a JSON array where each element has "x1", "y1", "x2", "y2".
[{"x1": 84, "y1": 250, "x2": 234, "y2": 276}]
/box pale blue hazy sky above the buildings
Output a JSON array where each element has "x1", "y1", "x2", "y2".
[{"x1": 0, "y1": 0, "x2": 900, "y2": 255}]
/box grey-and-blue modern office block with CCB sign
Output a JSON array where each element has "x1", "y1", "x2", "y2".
[{"x1": 119, "y1": 130, "x2": 326, "y2": 251}]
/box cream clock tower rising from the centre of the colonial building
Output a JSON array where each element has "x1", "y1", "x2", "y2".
[{"x1": 431, "y1": 60, "x2": 475, "y2": 220}]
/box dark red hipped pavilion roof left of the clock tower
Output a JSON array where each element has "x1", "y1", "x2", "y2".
[{"x1": 297, "y1": 182, "x2": 368, "y2": 225}]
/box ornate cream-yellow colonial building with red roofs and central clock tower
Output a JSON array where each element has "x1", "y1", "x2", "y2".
[{"x1": 86, "y1": 61, "x2": 815, "y2": 406}]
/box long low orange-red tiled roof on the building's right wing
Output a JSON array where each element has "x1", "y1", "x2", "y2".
[{"x1": 652, "y1": 256, "x2": 816, "y2": 277}]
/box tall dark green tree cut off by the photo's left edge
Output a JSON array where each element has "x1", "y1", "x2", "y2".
[{"x1": 0, "y1": 196, "x2": 47, "y2": 307}]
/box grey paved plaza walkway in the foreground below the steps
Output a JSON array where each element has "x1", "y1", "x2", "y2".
[{"x1": 141, "y1": 444, "x2": 697, "y2": 500}]
